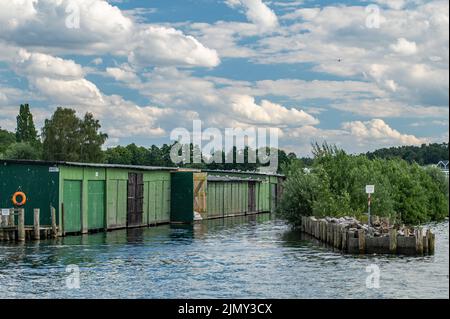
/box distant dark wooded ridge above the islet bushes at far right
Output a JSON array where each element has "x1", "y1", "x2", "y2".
[{"x1": 366, "y1": 143, "x2": 449, "y2": 166}]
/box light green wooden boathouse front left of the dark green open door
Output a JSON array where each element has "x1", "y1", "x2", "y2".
[{"x1": 60, "y1": 166, "x2": 171, "y2": 233}]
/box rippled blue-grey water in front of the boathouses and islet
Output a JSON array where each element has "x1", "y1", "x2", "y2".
[{"x1": 0, "y1": 215, "x2": 449, "y2": 298}]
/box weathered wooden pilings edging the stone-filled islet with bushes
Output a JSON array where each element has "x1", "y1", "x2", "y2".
[{"x1": 301, "y1": 216, "x2": 435, "y2": 255}]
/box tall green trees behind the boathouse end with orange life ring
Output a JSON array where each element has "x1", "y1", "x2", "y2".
[{"x1": 0, "y1": 104, "x2": 108, "y2": 163}]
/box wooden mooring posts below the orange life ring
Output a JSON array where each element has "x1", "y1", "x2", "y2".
[{"x1": 0, "y1": 207, "x2": 58, "y2": 242}]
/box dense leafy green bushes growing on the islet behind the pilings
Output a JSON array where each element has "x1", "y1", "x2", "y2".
[{"x1": 280, "y1": 144, "x2": 448, "y2": 225}]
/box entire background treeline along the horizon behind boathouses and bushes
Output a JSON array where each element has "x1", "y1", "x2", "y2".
[{"x1": 0, "y1": 104, "x2": 449, "y2": 172}]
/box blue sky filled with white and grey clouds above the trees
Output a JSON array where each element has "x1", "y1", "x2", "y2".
[{"x1": 0, "y1": 0, "x2": 449, "y2": 155}]
